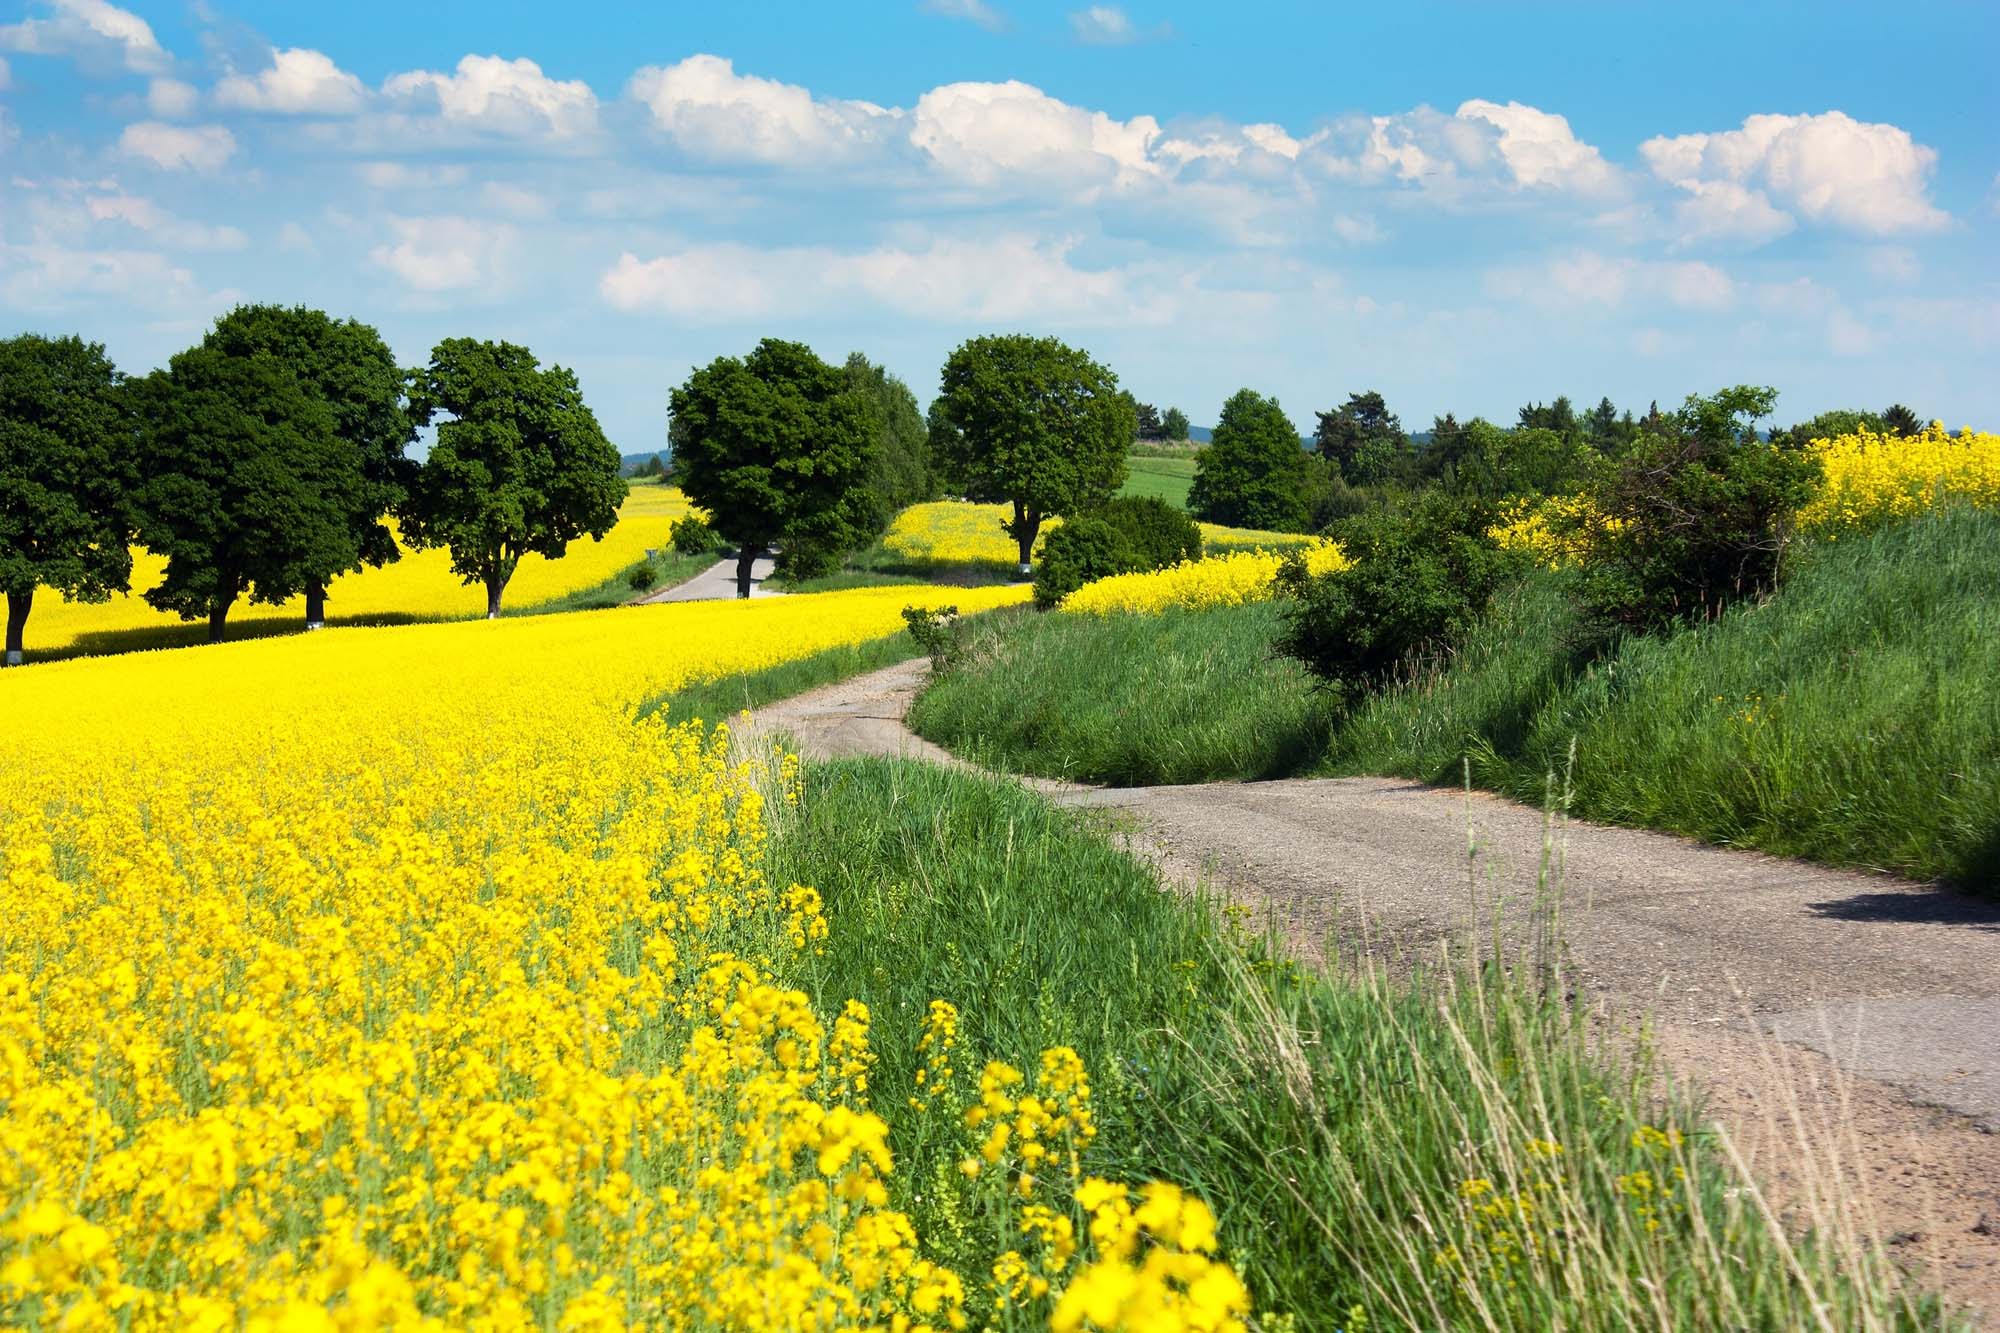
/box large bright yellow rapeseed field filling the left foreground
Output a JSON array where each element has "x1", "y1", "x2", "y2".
[{"x1": 0, "y1": 588, "x2": 1248, "y2": 1331}]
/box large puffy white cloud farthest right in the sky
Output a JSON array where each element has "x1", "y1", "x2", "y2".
[{"x1": 1640, "y1": 112, "x2": 1948, "y2": 234}]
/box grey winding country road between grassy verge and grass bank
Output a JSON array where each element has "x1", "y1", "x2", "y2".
[{"x1": 746, "y1": 662, "x2": 2000, "y2": 1313}]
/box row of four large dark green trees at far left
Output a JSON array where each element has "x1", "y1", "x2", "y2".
[{"x1": 0, "y1": 306, "x2": 626, "y2": 664}]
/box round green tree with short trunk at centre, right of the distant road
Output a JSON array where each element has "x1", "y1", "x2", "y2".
[{"x1": 932, "y1": 334, "x2": 1138, "y2": 576}]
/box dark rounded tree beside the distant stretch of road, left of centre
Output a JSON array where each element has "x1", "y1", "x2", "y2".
[{"x1": 668, "y1": 338, "x2": 876, "y2": 596}]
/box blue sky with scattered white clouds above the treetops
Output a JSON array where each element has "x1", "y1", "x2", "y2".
[{"x1": 0, "y1": 0, "x2": 2000, "y2": 452}]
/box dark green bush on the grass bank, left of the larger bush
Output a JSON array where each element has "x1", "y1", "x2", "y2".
[{"x1": 1276, "y1": 492, "x2": 1514, "y2": 701}]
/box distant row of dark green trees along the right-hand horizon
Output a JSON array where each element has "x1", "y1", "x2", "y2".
[{"x1": 1188, "y1": 388, "x2": 1922, "y2": 532}]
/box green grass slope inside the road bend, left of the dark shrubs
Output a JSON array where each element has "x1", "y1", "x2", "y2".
[{"x1": 910, "y1": 604, "x2": 1328, "y2": 787}]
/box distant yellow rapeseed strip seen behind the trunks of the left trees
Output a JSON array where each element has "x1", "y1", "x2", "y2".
[{"x1": 28, "y1": 482, "x2": 690, "y2": 650}]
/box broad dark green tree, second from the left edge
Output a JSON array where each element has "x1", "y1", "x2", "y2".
[{"x1": 130, "y1": 342, "x2": 368, "y2": 642}]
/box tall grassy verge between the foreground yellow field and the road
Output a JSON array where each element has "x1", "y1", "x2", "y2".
[{"x1": 770, "y1": 761, "x2": 1936, "y2": 1329}]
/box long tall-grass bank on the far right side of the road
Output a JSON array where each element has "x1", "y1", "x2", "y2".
[{"x1": 914, "y1": 510, "x2": 2000, "y2": 893}]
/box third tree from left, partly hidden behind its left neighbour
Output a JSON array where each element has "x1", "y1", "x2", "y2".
[{"x1": 202, "y1": 306, "x2": 416, "y2": 628}]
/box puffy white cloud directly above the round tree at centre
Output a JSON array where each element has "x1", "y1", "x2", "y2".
[{"x1": 910, "y1": 80, "x2": 1162, "y2": 188}]
